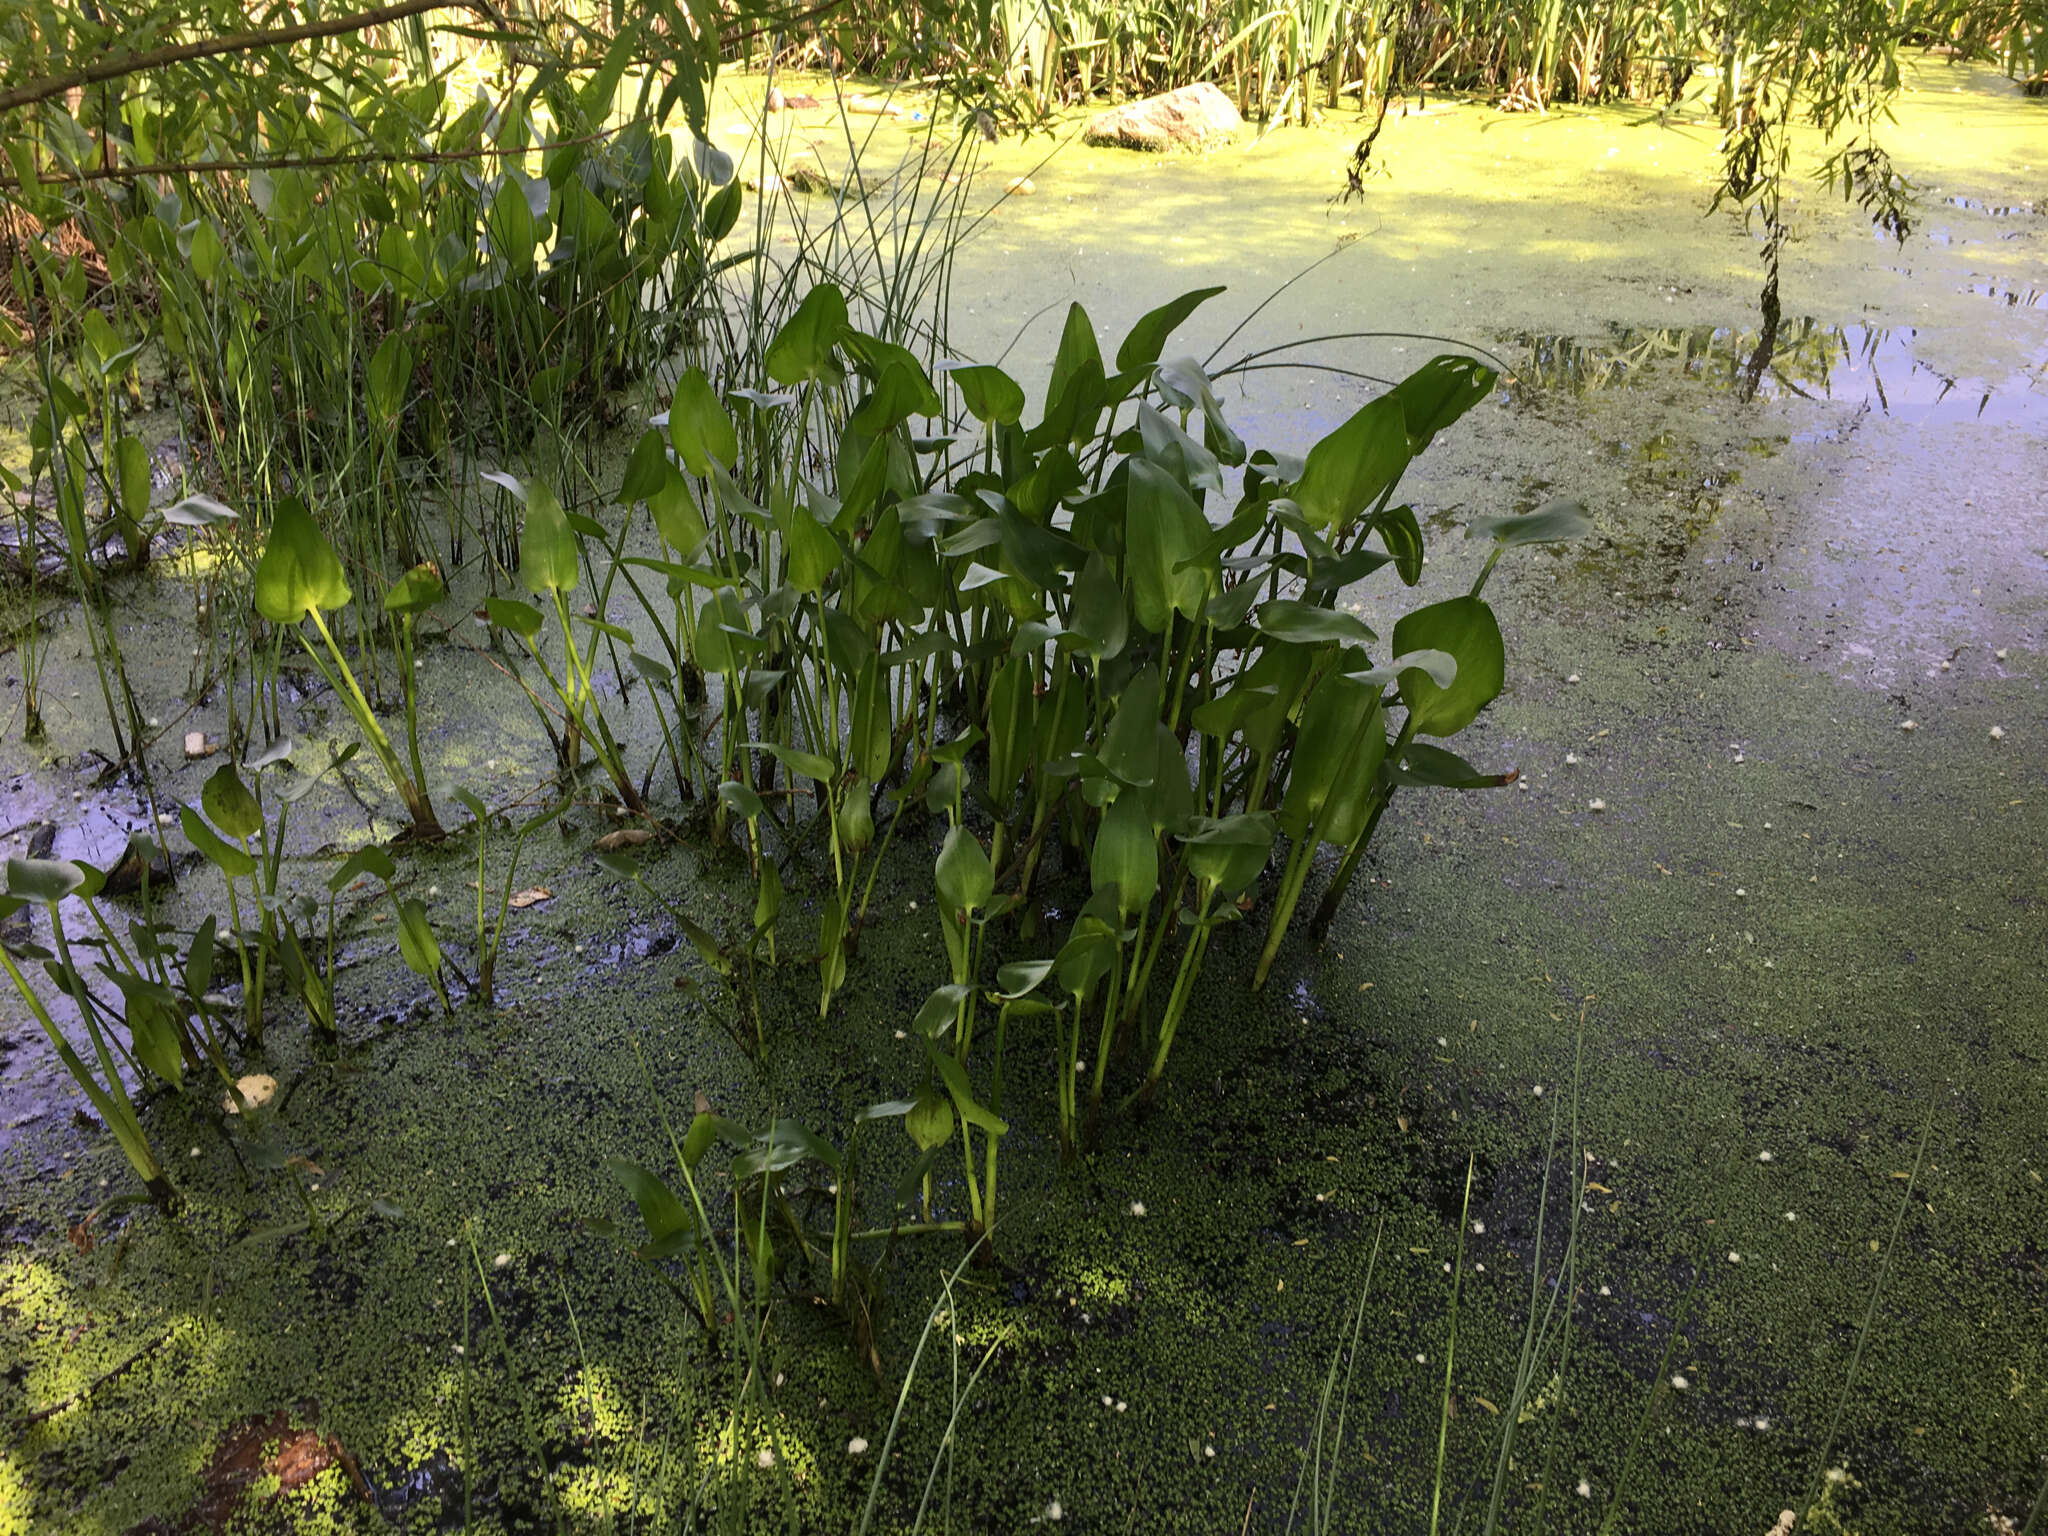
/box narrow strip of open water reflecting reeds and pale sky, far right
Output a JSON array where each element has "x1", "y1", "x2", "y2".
[{"x1": 1499, "y1": 319, "x2": 2048, "y2": 422}]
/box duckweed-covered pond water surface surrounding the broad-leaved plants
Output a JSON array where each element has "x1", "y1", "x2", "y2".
[{"x1": 0, "y1": 54, "x2": 2048, "y2": 1534}]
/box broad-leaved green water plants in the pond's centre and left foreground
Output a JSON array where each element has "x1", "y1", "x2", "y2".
[{"x1": 10, "y1": 274, "x2": 1583, "y2": 1253}]
